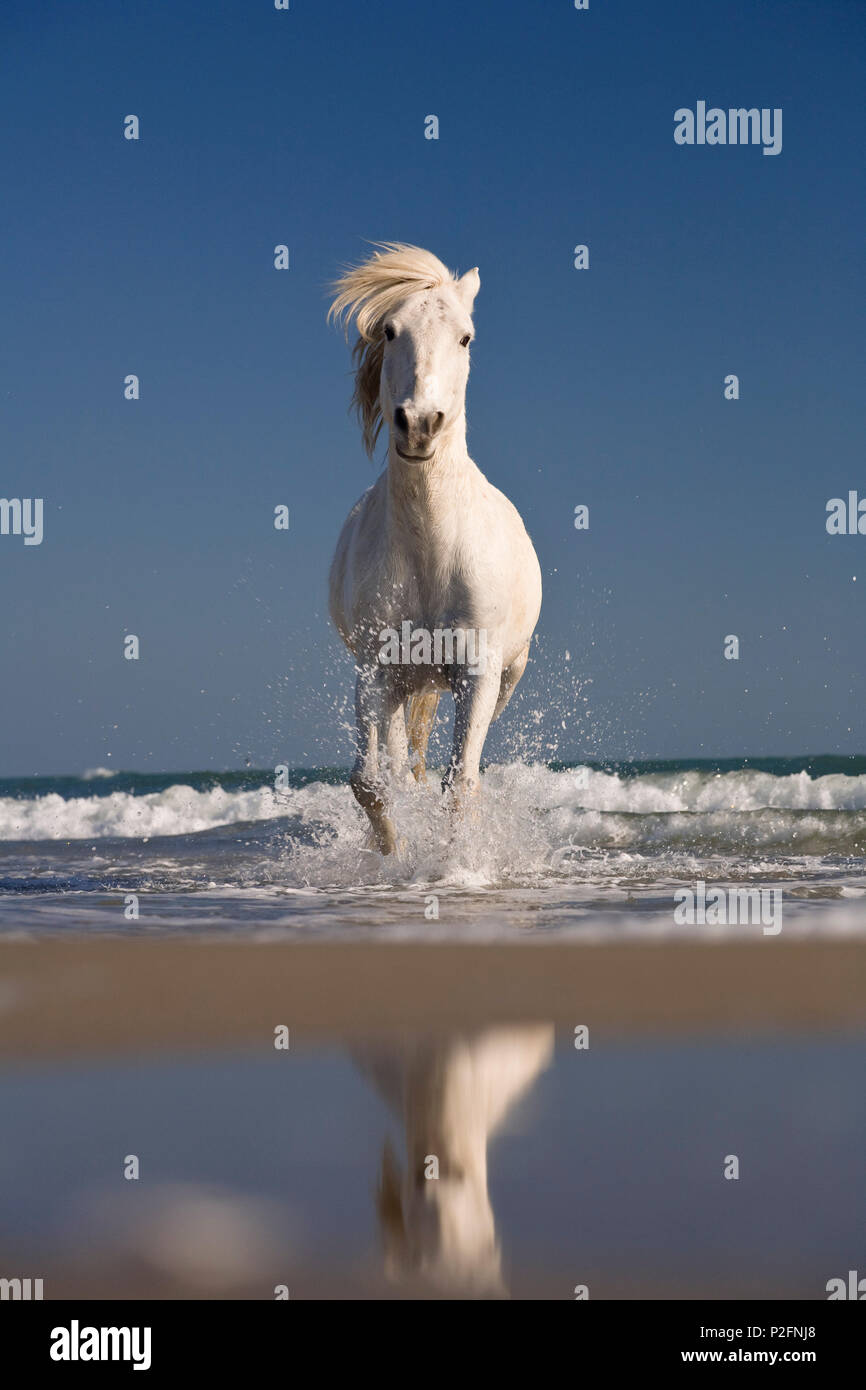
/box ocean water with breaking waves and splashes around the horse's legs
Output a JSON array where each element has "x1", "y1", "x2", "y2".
[{"x1": 0, "y1": 756, "x2": 866, "y2": 941}]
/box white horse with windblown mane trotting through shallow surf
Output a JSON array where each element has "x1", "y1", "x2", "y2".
[{"x1": 328, "y1": 242, "x2": 541, "y2": 855}]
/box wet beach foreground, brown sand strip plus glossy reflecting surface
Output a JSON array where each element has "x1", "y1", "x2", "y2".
[{"x1": 0, "y1": 926, "x2": 866, "y2": 1300}]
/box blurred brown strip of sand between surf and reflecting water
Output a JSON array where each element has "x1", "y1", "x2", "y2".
[{"x1": 0, "y1": 937, "x2": 866, "y2": 1062}]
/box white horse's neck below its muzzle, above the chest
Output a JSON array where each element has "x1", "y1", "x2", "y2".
[{"x1": 388, "y1": 417, "x2": 475, "y2": 541}]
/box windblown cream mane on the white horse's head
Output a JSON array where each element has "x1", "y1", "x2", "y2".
[{"x1": 328, "y1": 242, "x2": 455, "y2": 457}]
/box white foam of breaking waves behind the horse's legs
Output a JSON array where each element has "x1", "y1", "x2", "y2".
[{"x1": 0, "y1": 763, "x2": 866, "y2": 855}]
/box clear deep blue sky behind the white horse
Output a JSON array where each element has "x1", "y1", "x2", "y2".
[{"x1": 0, "y1": 0, "x2": 866, "y2": 776}]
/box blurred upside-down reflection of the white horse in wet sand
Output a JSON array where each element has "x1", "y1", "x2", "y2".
[{"x1": 356, "y1": 1023, "x2": 553, "y2": 1298}]
